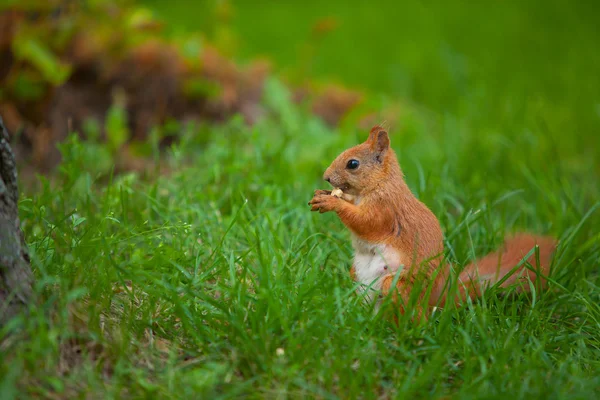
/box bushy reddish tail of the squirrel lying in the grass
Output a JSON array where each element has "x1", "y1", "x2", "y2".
[{"x1": 458, "y1": 233, "x2": 558, "y2": 300}]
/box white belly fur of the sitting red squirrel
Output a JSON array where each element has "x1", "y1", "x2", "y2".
[{"x1": 352, "y1": 235, "x2": 402, "y2": 298}]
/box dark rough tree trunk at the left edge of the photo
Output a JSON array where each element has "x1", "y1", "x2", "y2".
[{"x1": 0, "y1": 117, "x2": 33, "y2": 325}]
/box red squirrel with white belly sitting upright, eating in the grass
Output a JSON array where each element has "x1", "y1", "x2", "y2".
[{"x1": 308, "y1": 125, "x2": 558, "y2": 318}]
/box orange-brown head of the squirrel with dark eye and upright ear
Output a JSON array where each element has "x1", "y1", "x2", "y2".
[{"x1": 323, "y1": 125, "x2": 397, "y2": 196}]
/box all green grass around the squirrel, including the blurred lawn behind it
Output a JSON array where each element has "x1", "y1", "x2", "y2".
[{"x1": 0, "y1": 0, "x2": 600, "y2": 399}]
